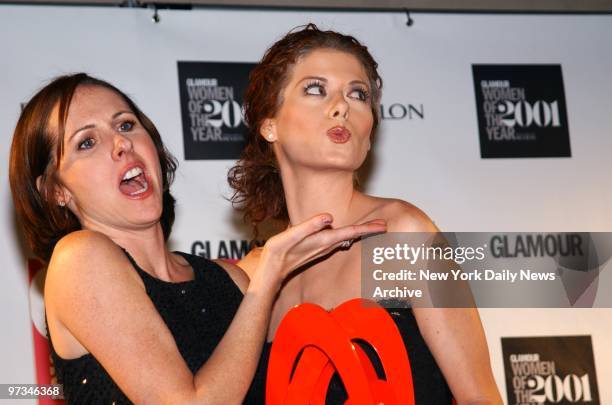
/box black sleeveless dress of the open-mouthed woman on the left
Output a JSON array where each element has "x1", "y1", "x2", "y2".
[{"x1": 49, "y1": 252, "x2": 264, "y2": 405}]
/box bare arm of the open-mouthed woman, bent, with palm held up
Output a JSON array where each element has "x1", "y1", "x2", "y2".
[{"x1": 45, "y1": 217, "x2": 382, "y2": 404}]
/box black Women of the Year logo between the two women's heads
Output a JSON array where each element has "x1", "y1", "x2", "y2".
[{"x1": 178, "y1": 62, "x2": 253, "y2": 160}]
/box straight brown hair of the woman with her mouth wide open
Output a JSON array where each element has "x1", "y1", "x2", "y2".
[{"x1": 9, "y1": 73, "x2": 177, "y2": 262}]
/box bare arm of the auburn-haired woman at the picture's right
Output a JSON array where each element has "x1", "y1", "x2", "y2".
[{"x1": 389, "y1": 203, "x2": 503, "y2": 405}]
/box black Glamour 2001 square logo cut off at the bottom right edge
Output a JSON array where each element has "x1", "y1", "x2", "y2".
[{"x1": 502, "y1": 336, "x2": 600, "y2": 405}]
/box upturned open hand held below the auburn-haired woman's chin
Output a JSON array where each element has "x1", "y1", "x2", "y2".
[{"x1": 253, "y1": 214, "x2": 387, "y2": 288}]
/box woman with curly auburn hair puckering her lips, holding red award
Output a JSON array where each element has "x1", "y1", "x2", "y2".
[{"x1": 228, "y1": 24, "x2": 501, "y2": 405}]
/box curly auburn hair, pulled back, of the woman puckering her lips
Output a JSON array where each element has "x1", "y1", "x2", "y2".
[{"x1": 228, "y1": 23, "x2": 382, "y2": 237}]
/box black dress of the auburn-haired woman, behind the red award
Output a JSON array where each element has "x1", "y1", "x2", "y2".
[{"x1": 246, "y1": 308, "x2": 452, "y2": 405}]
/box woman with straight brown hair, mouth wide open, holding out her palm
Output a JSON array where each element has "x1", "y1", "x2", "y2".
[{"x1": 9, "y1": 73, "x2": 385, "y2": 404}]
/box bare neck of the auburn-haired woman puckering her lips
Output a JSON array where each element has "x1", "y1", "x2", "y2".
[{"x1": 281, "y1": 164, "x2": 361, "y2": 228}]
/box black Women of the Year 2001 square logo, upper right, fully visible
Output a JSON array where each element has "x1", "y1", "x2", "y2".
[{"x1": 472, "y1": 65, "x2": 571, "y2": 158}]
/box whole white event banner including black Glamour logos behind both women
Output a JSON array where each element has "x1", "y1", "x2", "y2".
[{"x1": 0, "y1": 5, "x2": 612, "y2": 404}]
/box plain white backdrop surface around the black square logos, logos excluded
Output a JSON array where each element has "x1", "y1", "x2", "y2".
[{"x1": 0, "y1": 5, "x2": 612, "y2": 403}]
